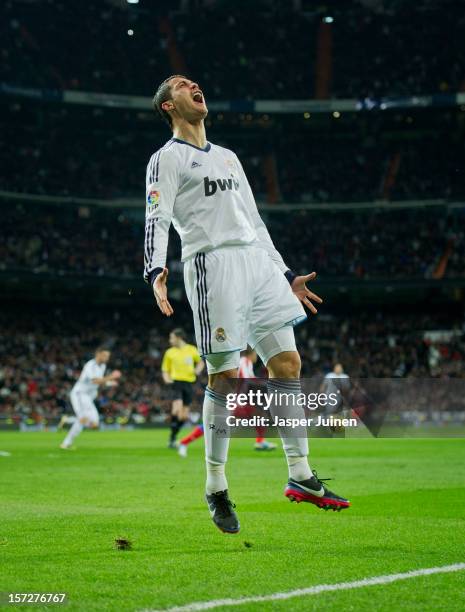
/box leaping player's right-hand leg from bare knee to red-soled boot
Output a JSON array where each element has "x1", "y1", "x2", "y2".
[{"x1": 267, "y1": 351, "x2": 350, "y2": 511}]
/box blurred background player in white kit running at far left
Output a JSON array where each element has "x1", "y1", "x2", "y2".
[{"x1": 60, "y1": 347, "x2": 121, "y2": 450}]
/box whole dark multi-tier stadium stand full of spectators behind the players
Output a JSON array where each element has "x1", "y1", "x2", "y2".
[{"x1": 0, "y1": 0, "x2": 465, "y2": 422}]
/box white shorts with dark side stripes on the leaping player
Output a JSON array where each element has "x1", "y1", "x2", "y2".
[{"x1": 184, "y1": 246, "x2": 306, "y2": 356}]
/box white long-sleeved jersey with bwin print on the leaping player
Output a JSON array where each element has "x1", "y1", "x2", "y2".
[{"x1": 144, "y1": 138, "x2": 288, "y2": 281}]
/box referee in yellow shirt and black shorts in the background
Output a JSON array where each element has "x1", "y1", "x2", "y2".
[{"x1": 161, "y1": 327, "x2": 204, "y2": 448}]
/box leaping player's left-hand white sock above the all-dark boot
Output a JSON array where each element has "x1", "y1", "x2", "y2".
[{"x1": 203, "y1": 387, "x2": 229, "y2": 495}]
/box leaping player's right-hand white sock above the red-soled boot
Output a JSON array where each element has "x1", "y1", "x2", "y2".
[{"x1": 267, "y1": 378, "x2": 313, "y2": 480}]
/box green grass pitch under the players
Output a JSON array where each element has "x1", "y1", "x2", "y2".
[{"x1": 0, "y1": 430, "x2": 465, "y2": 612}]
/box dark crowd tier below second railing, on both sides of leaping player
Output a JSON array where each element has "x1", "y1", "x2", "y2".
[{"x1": 0, "y1": 203, "x2": 465, "y2": 279}]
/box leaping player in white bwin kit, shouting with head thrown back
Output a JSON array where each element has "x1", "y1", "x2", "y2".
[{"x1": 144, "y1": 75, "x2": 350, "y2": 533}]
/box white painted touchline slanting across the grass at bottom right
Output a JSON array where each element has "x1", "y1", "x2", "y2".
[{"x1": 142, "y1": 563, "x2": 465, "y2": 612}]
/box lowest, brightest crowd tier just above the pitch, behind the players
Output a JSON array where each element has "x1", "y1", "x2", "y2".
[{"x1": 0, "y1": 304, "x2": 465, "y2": 422}]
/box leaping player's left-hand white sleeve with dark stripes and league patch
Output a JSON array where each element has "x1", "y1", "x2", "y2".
[{"x1": 144, "y1": 149, "x2": 179, "y2": 282}]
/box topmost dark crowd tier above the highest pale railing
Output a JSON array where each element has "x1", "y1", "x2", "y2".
[{"x1": 0, "y1": 0, "x2": 465, "y2": 100}]
